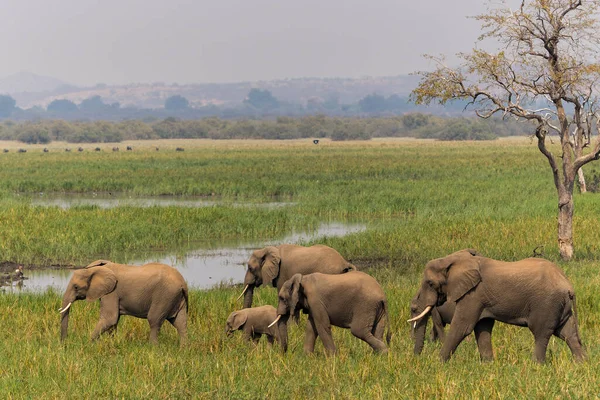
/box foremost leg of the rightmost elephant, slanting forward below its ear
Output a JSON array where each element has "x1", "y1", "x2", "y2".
[{"x1": 440, "y1": 292, "x2": 483, "y2": 362}]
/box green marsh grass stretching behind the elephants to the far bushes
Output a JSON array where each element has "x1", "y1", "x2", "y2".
[{"x1": 0, "y1": 139, "x2": 599, "y2": 265}]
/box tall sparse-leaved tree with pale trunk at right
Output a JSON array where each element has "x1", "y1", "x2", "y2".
[{"x1": 411, "y1": 0, "x2": 600, "y2": 260}]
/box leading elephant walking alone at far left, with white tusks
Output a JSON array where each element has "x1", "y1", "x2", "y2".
[{"x1": 59, "y1": 260, "x2": 188, "y2": 345}]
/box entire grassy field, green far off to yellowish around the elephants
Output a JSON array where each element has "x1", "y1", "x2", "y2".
[{"x1": 0, "y1": 138, "x2": 600, "y2": 399}]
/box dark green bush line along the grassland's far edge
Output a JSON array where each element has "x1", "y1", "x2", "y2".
[{"x1": 0, "y1": 113, "x2": 531, "y2": 144}]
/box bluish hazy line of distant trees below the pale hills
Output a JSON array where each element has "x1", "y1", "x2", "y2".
[{"x1": 0, "y1": 88, "x2": 474, "y2": 122}]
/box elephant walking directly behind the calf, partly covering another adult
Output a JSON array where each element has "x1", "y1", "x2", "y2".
[{"x1": 277, "y1": 271, "x2": 391, "y2": 355}]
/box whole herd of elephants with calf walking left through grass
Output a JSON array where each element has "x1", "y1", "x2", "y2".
[{"x1": 59, "y1": 244, "x2": 586, "y2": 363}]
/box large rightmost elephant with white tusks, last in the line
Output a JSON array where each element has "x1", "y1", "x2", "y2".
[{"x1": 409, "y1": 249, "x2": 586, "y2": 363}]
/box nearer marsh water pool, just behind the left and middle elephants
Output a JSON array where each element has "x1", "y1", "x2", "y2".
[{"x1": 10, "y1": 222, "x2": 366, "y2": 292}]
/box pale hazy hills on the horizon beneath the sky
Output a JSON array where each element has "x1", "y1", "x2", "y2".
[{"x1": 0, "y1": 72, "x2": 418, "y2": 108}]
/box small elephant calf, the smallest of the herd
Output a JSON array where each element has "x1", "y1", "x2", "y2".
[{"x1": 225, "y1": 306, "x2": 279, "y2": 344}]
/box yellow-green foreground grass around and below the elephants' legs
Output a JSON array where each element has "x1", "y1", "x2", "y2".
[{"x1": 0, "y1": 264, "x2": 600, "y2": 399}]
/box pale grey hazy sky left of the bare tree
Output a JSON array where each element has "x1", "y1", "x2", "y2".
[{"x1": 0, "y1": 0, "x2": 516, "y2": 85}]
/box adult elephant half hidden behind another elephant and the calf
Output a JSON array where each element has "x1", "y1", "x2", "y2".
[{"x1": 238, "y1": 244, "x2": 356, "y2": 308}]
